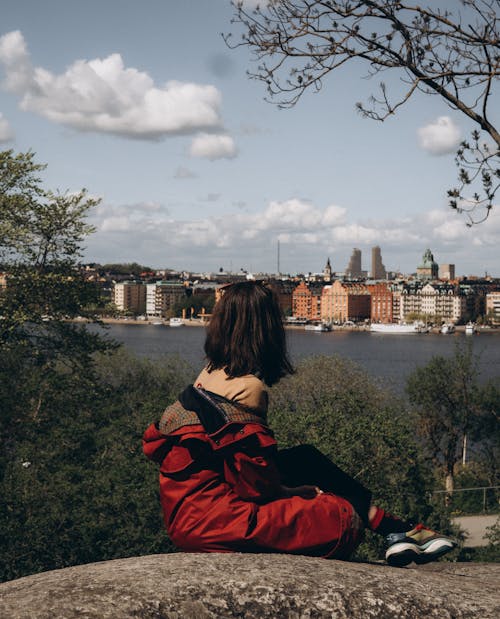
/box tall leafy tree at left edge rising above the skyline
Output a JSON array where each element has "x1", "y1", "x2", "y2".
[{"x1": 0, "y1": 150, "x2": 113, "y2": 472}]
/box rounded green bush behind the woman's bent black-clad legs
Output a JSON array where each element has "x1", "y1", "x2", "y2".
[{"x1": 270, "y1": 357, "x2": 448, "y2": 558}]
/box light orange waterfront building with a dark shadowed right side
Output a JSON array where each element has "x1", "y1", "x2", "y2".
[{"x1": 321, "y1": 280, "x2": 370, "y2": 322}]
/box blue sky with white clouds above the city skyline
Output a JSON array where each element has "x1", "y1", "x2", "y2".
[{"x1": 0, "y1": 0, "x2": 500, "y2": 277}]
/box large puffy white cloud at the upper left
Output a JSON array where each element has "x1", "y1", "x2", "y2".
[{"x1": 0, "y1": 31, "x2": 222, "y2": 140}]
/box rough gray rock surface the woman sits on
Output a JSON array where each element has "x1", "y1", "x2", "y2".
[{"x1": 0, "y1": 553, "x2": 500, "y2": 619}]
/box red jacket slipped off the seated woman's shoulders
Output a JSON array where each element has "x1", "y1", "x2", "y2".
[{"x1": 143, "y1": 403, "x2": 360, "y2": 558}]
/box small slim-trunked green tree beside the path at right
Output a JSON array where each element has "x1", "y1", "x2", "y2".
[{"x1": 407, "y1": 345, "x2": 498, "y2": 493}]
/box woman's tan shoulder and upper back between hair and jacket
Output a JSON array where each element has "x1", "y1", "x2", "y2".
[{"x1": 194, "y1": 368, "x2": 268, "y2": 412}]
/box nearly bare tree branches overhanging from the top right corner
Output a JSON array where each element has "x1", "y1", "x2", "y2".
[{"x1": 229, "y1": 0, "x2": 500, "y2": 224}]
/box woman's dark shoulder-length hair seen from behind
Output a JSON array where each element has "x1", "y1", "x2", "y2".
[{"x1": 205, "y1": 281, "x2": 294, "y2": 386}]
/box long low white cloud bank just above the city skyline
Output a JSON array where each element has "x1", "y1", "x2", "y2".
[{"x1": 87, "y1": 198, "x2": 500, "y2": 276}]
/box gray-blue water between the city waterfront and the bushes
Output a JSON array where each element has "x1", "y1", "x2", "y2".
[{"x1": 94, "y1": 324, "x2": 500, "y2": 392}]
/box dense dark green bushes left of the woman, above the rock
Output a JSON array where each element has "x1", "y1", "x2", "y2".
[{"x1": 0, "y1": 351, "x2": 193, "y2": 580}]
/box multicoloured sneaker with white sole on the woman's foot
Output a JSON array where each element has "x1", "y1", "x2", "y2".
[{"x1": 385, "y1": 524, "x2": 456, "y2": 567}]
